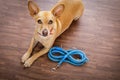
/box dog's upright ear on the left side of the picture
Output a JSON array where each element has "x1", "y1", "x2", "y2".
[{"x1": 28, "y1": 0, "x2": 40, "y2": 17}]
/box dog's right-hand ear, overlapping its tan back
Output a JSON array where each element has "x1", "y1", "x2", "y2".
[{"x1": 51, "y1": 4, "x2": 65, "y2": 17}]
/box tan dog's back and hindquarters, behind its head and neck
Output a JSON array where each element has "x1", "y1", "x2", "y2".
[{"x1": 51, "y1": 0, "x2": 84, "y2": 34}]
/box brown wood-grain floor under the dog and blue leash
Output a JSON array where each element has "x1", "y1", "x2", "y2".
[{"x1": 0, "y1": 0, "x2": 120, "y2": 80}]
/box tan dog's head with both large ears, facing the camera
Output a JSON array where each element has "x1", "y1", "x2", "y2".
[{"x1": 28, "y1": 1, "x2": 64, "y2": 37}]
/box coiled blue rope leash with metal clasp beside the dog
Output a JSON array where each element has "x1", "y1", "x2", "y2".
[{"x1": 48, "y1": 47, "x2": 88, "y2": 70}]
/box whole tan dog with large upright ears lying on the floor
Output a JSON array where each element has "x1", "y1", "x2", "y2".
[{"x1": 22, "y1": 0, "x2": 84, "y2": 67}]
